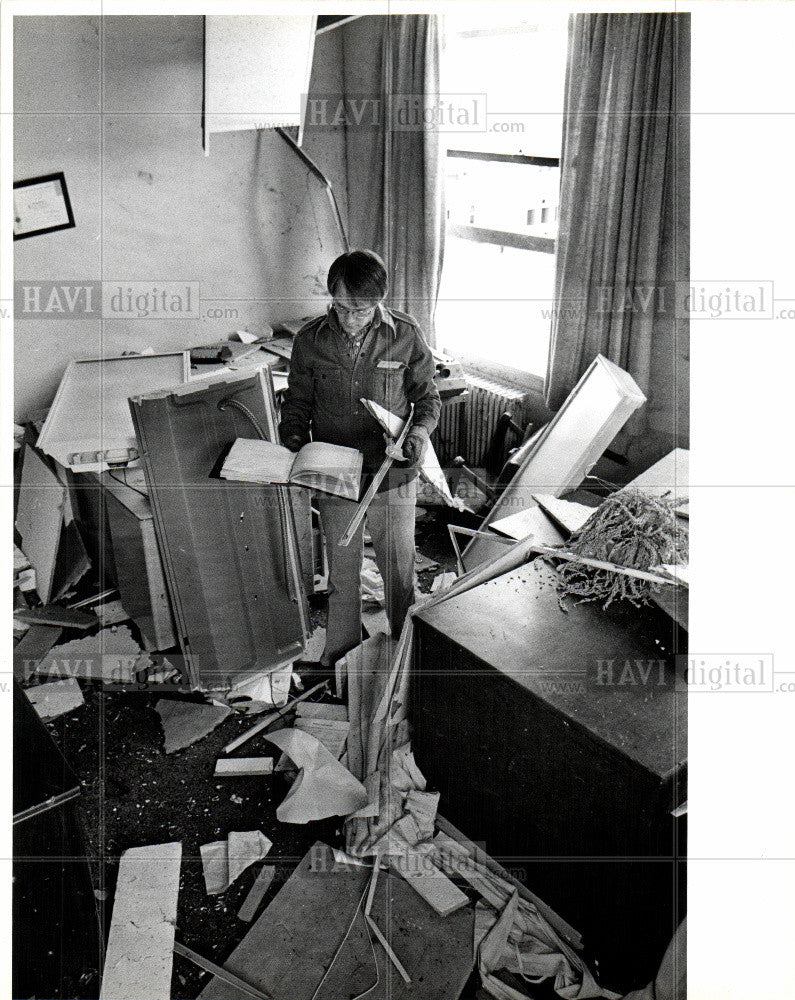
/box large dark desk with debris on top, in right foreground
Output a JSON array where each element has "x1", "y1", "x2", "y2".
[{"x1": 411, "y1": 562, "x2": 687, "y2": 992}]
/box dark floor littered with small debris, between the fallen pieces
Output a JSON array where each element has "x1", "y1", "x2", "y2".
[{"x1": 18, "y1": 508, "x2": 474, "y2": 1000}]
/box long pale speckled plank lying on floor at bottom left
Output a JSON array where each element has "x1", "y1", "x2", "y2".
[{"x1": 100, "y1": 843, "x2": 182, "y2": 1000}]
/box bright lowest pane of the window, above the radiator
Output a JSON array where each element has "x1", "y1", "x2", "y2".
[{"x1": 435, "y1": 237, "x2": 555, "y2": 376}]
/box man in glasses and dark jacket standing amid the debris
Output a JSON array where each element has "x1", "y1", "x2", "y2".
[{"x1": 279, "y1": 250, "x2": 441, "y2": 667}]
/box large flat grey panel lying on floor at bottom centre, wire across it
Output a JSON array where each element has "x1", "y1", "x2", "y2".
[{"x1": 200, "y1": 844, "x2": 474, "y2": 1000}]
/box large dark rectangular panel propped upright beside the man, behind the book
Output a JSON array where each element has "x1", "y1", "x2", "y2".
[{"x1": 130, "y1": 371, "x2": 307, "y2": 686}]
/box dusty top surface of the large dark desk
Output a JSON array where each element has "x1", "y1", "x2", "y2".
[{"x1": 418, "y1": 560, "x2": 687, "y2": 777}]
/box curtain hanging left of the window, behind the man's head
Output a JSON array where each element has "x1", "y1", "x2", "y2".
[{"x1": 325, "y1": 14, "x2": 444, "y2": 344}]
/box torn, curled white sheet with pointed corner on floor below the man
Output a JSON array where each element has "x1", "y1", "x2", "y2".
[{"x1": 265, "y1": 729, "x2": 367, "y2": 823}]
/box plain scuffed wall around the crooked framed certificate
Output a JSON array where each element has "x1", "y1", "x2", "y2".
[{"x1": 14, "y1": 15, "x2": 342, "y2": 420}]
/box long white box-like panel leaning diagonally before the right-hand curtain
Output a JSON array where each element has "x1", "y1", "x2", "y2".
[{"x1": 463, "y1": 354, "x2": 646, "y2": 570}]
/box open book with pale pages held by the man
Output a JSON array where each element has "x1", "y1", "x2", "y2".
[{"x1": 221, "y1": 438, "x2": 362, "y2": 500}]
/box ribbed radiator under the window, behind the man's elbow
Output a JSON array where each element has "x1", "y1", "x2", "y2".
[{"x1": 433, "y1": 374, "x2": 530, "y2": 467}]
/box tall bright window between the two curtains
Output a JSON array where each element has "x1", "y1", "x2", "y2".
[{"x1": 436, "y1": 12, "x2": 567, "y2": 376}]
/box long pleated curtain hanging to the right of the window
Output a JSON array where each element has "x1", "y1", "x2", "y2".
[{"x1": 546, "y1": 13, "x2": 689, "y2": 456}]
